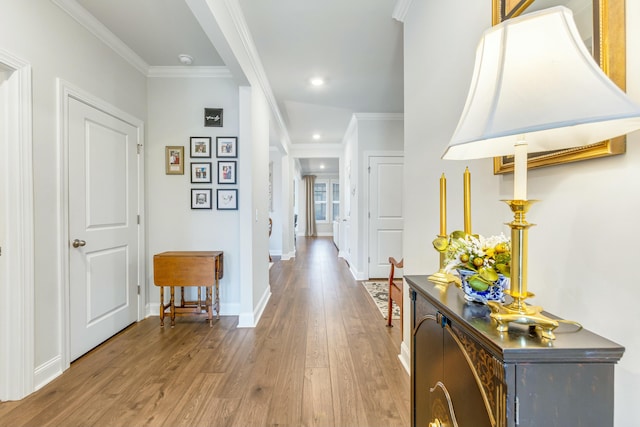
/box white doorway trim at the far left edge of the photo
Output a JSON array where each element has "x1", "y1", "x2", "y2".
[{"x1": 0, "y1": 50, "x2": 35, "y2": 400}]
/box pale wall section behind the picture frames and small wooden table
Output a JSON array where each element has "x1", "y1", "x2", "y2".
[{"x1": 145, "y1": 76, "x2": 241, "y2": 315}]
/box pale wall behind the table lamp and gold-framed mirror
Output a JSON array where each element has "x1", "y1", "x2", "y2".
[{"x1": 404, "y1": 0, "x2": 640, "y2": 427}]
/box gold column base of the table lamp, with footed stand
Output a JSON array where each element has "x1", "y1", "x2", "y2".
[{"x1": 488, "y1": 200, "x2": 559, "y2": 340}]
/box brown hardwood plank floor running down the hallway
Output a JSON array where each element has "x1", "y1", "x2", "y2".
[{"x1": 0, "y1": 238, "x2": 410, "y2": 427}]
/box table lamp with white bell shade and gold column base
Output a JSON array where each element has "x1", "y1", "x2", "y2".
[{"x1": 442, "y1": 6, "x2": 640, "y2": 339}]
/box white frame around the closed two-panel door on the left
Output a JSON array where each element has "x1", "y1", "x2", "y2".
[{"x1": 56, "y1": 78, "x2": 147, "y2": 371}]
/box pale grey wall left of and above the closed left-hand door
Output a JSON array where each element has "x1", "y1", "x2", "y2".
[{"x1": 0, "y1": 0, "x2": 146, "y2": 386}]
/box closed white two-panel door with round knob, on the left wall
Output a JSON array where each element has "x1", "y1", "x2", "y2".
[{"x1": 69, "y1": 98, "x2": 138, "y2": 361}]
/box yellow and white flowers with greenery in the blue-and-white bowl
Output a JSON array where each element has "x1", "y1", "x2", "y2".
[{"x1": 434, "y1": 231, "x2": 511, "y2": 291}]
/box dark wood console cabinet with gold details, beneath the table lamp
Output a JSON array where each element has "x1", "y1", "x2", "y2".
[{"x1": 405, "y1": 276, "x2": 624, "y2": 427}]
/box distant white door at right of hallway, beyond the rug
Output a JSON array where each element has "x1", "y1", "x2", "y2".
[{"x1": 369, "y1": 157, "x2": 404, "y2": 278}]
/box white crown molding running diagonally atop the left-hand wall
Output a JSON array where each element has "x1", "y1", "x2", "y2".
[{"x1": 51, "y1": 0, "x2": 149, "y2": 75}]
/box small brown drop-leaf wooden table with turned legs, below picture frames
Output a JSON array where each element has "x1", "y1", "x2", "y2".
[{"x1": 153, "y1": 251, "x2": 224, "y2": 327}]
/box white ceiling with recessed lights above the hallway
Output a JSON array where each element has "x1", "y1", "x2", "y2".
[{"x1": 66, "y1": 0, "x2": 403, "y2": 173}]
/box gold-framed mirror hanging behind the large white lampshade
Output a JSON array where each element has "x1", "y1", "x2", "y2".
[{"x1": 492, "y1": 0, "x2": 626, "y2": 174}]
